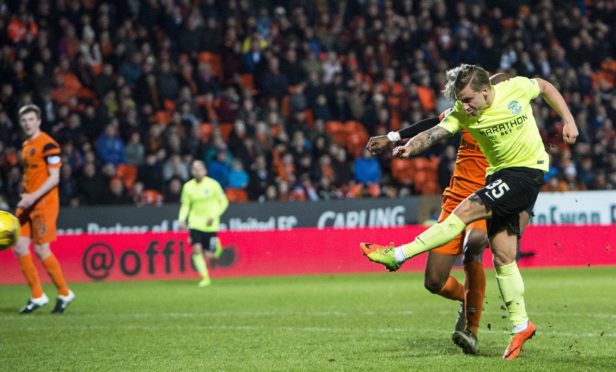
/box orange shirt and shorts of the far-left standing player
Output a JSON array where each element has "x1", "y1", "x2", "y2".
[{"x1": 17, "y1": 132, "x2": 62, "y2": 244}]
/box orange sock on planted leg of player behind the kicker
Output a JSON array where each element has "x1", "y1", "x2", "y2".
[{"x1": 464, "y1": 260, "x2": 486, "y2": 336}]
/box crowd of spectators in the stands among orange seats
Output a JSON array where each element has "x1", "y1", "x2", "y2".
[{"x1": 0, "y1": 0, "x2": 616, "y2": 208}]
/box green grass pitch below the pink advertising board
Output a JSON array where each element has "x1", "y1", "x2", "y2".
[{"x1": 0, "y1": 268, "x2": 616, "y2": 371}]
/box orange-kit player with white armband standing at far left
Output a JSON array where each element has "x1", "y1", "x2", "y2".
[{"x1": 13, "y1": 105, "x2": 75, "y2": 314}]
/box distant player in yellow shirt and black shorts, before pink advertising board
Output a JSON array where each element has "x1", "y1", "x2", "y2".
[{"x1": 178, "y1": 160, "x2": 229, "y2": 287}]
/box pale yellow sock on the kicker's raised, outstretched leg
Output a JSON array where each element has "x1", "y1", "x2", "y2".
[{"x1": 400, "y1": 213, "x2": 466, "y2": 258}]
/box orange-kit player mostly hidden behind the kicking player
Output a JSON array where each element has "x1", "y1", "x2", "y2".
[{"x1": 366, "y1": 73, "x2": 511, "y2": 354}]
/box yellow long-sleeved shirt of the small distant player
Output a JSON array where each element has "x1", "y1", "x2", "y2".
[{"x1": 179, "y1": 177, "x2": 229, "y2": 232}]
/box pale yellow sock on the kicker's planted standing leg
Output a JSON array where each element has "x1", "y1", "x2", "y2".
[{"x1": 496, "y1": 262, "x2": 528, "y2": 329}]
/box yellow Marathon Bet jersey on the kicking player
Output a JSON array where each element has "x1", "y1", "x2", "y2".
[{"x1": 439, "y1": 76, "x2": 549, "y2": 175}]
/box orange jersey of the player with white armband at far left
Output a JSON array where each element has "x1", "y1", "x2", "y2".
[{"x1": 21, "y1": 132, "x2": 62, "y2": 208}]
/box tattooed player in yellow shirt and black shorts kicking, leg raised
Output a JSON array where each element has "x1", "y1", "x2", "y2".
[{"x1": 362, "y1": 65, "x2": 578, "y2": 360}]
